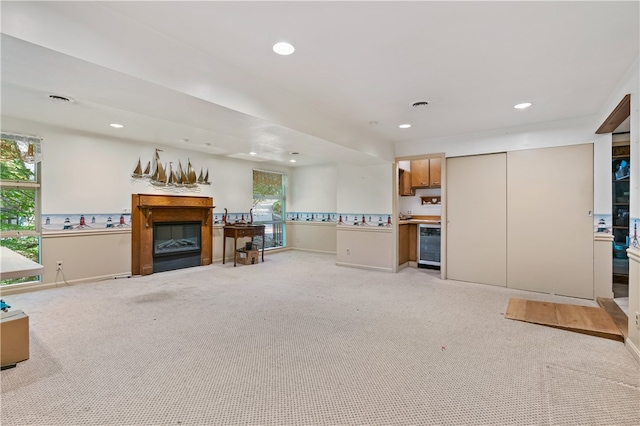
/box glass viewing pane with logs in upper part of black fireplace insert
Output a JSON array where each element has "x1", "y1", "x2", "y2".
[{"x1": 153, "y1": 222, "x2": 201, "y2": 256}]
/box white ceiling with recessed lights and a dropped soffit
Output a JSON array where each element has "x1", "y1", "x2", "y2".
[{"x1": 0, "y1": 1, "x2": 640, "y2": 165}]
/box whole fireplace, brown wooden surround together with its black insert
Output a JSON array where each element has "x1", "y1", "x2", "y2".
[{"x1": 131, "y1": 194, "x2": 215, "y2": 275}]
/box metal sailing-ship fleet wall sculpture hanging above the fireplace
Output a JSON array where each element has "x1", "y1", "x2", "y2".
[{"x1": 131, "y1": 148, "x2": 211, "y2": 190}]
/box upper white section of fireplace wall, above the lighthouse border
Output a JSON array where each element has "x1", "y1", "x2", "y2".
[{"x1": 33, "y1": 123, "x2": 290, "y2": 214}]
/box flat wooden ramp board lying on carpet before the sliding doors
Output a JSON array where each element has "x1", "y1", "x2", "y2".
[{"x1": 504, "y1": 299, "x2": 624, "y2": 342}]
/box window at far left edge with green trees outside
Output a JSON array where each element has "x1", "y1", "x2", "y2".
[{"x1": 0, "y1": 133, "x2": 40, "y2": 285}]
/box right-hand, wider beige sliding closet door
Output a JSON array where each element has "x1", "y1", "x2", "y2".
[{"x1": 508, "y1": 144, "x2": 593, "y2": 299}]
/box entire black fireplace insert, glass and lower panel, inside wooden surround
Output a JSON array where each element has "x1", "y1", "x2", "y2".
[{"x1": 153, "y1": 222, "x2": 202, "y2": 272}]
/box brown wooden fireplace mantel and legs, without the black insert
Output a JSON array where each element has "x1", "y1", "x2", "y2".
[{"x1": 131, "y1": 194, "x2": 215, "y2": 275}]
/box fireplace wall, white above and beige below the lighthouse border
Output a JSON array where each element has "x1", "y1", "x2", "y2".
[{"x1": 3, "y1": 118, "x2": 292, "y2": 285}]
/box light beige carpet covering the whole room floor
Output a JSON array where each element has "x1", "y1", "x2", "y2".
[{"x1": 0, "y1": 251, "x2": 640, "y2": 426}]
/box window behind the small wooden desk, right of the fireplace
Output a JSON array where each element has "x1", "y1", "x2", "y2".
[{"x1": 253, "y1": 170, "x2": 286, "y2": 248}]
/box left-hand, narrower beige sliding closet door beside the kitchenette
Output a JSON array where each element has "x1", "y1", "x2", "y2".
[{"x1": 446, "y1": 153, "x2": 507, "y2": 287}]
